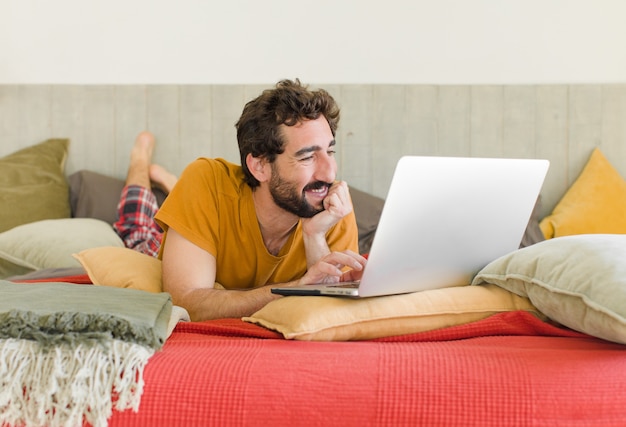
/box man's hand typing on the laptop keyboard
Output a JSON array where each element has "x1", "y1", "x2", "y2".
[{"x1": 297, "y1": 251, "x2": 367, "y2": 285}]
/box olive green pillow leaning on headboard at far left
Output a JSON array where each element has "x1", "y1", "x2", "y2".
[{"x1": 0, "y1": 139, "x2": 71, "y2": 232}]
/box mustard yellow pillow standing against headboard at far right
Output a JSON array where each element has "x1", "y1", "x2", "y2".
[{"x1": 539, "y1": 148, "x2": 626, "y2": 239}]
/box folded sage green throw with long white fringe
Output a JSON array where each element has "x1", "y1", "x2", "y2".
[{"x1": 0, "y1": 280, "x2": 172, "y2": 427}]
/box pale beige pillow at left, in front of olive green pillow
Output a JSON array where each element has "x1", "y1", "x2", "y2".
[{"x1": 0, "y1": 218, "x2": 124, "y2": 278}]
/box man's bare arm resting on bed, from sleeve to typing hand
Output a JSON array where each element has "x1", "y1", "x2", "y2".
[{"x1": 162, "y1": 228, "x2": 365, "y2": 321}]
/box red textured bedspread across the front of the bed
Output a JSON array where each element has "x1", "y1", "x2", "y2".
[{"x1": 106, "y1": 312, "x2": 626, "y2": 426}]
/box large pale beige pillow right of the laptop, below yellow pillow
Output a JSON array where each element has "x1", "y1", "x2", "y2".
[{"x1": 473, "y1": 234, "x2": 626, "y2": 344}]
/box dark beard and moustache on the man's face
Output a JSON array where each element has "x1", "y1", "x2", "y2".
[{"x1": 269, "y1": 165, "x2": 330, "y2": 218}]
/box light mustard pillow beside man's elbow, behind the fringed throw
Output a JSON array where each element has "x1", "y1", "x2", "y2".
[{"x1": 74, "y1": 246, "x2": 163, "y2": 292}]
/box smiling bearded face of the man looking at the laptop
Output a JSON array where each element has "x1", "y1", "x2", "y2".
[{"x1": 269, "y1": 117, "x2": 337, "y2": 218}]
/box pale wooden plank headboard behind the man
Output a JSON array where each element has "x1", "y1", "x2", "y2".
[{"x1": 0, "y1": 84, "x2": 626, "y2": 214}]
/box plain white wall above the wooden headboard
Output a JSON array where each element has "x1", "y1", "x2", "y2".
[{"x1": 0, "y1": 0, "x2": 626, "y2": 84}]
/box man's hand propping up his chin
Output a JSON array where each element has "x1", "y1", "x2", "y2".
[{"x1": 302, "y1": 181, "x2": 353, "y2": 236}]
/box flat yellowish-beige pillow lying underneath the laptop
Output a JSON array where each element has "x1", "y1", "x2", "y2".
[{"x1": 243, "y1": 286, "x2": 539, "y2": 341}]
